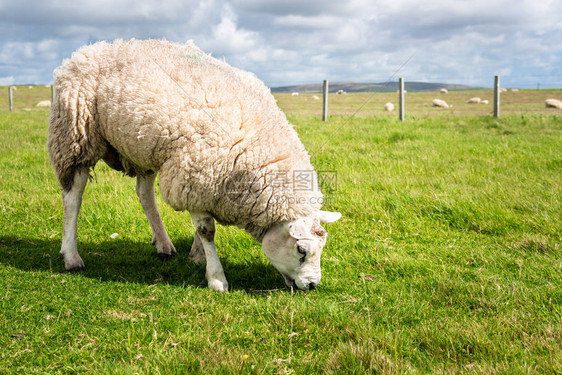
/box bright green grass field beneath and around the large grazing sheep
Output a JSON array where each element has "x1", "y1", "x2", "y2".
[{"x1": 0, "y1": 87, "x2": 562, "y2": 374}]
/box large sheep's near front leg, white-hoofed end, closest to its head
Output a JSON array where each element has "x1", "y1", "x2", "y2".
[{"x1": 190, "y1": 212, "x2": 228, "y2": 292}]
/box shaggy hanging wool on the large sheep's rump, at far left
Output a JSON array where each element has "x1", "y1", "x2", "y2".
[{"x1": 48, "y1": 66, "x2": 105, "y2": 191}]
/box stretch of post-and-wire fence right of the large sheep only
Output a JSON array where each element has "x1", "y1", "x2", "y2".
[{"x1": 274, "y1": 77, "x2": 562, "y2": 120}]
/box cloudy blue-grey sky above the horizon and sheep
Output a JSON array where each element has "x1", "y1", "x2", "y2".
[{"x1": 0, "y1": 0, "x2": 562, "y2": 88}]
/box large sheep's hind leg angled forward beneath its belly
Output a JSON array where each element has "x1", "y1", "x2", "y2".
[{"x1": 136, "y1": 173, "x2": 177, "y2": 260}]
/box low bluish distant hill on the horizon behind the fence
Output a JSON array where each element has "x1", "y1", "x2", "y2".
[{"x1": 271, "y1": 81, "x2": 482, "y2": 93}]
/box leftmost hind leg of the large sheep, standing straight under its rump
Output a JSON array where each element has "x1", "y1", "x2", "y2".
[{"x1": 60, "y1": 169, "x2": 89, "y2": 271}]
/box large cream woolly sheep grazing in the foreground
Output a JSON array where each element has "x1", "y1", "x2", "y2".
[{"x1": 48, "y1": 40, "x2": 341, "y2": 291}]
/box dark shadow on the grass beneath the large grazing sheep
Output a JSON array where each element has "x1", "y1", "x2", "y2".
[{"x1": 0, "y1": 236, "x2": 285, "y2": 293}]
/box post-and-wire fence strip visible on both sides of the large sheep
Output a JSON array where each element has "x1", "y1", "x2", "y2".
[{"x1": 0, "y1": 76, "x2": 562, "y2": 120}]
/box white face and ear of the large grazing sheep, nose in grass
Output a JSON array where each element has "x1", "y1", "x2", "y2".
[{"x1": 262, "y1": 211, "x2": 341, "y2": 290}]
